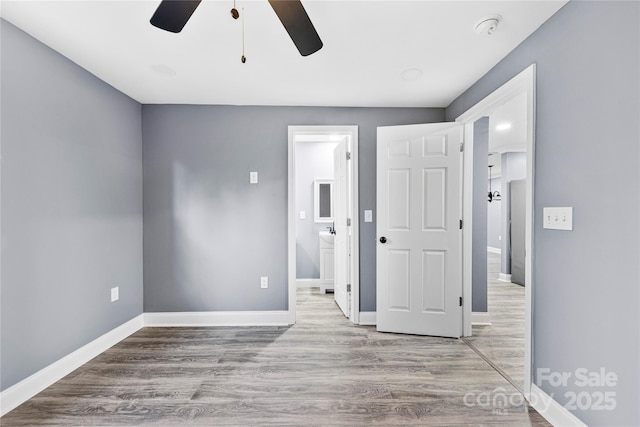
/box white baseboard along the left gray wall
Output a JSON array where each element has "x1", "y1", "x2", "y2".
[{"x1": 0, "y1": 314, "x2": 144, "y2": 416}]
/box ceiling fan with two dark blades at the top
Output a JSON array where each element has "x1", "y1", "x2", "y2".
[{"x1": 151, "y1": 0, "x2": 322, "y2": 56}]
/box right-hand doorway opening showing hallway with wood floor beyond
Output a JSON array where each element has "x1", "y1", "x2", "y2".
[{"x1": 465, "y1": 93, "x2": 527, "y2": 393}]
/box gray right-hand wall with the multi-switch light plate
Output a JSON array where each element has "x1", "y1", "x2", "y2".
[{"x1": 447, "y1": 1, "x2": 640, "y2": 426}]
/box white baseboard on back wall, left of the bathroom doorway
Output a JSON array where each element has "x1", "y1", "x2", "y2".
[{"x1": 144, "y1": 310, "x2": 289, "y2": 327}]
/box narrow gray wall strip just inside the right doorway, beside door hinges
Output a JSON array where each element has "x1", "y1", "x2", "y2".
[{"x1": 471, "y1": 117, "x2": 489, "y2": 312}]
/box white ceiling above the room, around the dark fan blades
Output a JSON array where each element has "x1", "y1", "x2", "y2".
[{"x1": 0, "y1": 0, "x2": 566, "y2": 107}]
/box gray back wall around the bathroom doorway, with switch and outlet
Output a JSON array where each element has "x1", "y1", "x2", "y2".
[{"x1": 142, "y1": 105, "x2": 444, "y2": 312}]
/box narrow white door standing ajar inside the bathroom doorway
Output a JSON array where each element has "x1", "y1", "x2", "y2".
[{"x1": 333, "y1": 138, "x2": 351, "y2": 317}]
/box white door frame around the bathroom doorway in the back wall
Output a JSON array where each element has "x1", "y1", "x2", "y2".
[{"x1": 287, "y1": 126, "x2": 360, "y2": 325}]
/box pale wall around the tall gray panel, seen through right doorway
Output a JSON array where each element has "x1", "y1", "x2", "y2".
[{"x1": 499, "y1": 153, "x2": 527, "y2": 274}]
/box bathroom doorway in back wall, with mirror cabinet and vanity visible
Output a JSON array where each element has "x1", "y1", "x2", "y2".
[{"x1": 288, "y1": 126, "x2": 359, "y2": 324}]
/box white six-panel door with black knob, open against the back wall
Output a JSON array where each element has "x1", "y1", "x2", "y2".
[{"x1": 376, "y1": 123, "x2": 463, "y2": 337}]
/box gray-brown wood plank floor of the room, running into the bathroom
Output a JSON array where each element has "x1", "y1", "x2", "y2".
[{"x1": 0, "y1": 288, "x2": 548, "y2": 427}]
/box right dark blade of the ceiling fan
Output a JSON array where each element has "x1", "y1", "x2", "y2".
[{"x1": 269, "y1": 0, "x2": 322, "y2": 56}]
